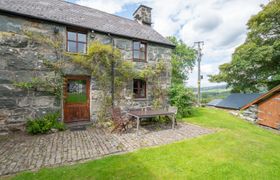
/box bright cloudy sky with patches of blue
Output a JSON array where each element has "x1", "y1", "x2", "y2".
[{"x1": 65, "y1": 0, "x2": 269, "y2": 87}]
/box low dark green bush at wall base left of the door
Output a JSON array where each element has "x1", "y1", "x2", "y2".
[{"x1": 26, "y1": 112, "x2": 66, "y2": 134}]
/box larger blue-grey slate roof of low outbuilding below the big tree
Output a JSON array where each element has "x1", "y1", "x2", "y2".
[{"x1": 215, "y1": 93, "x2": 262, "y2": 110}]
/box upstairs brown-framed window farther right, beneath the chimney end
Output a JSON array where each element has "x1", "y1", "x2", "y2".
[{"x1": 132, "y1": 41, "x2": 147, "y2": 61}]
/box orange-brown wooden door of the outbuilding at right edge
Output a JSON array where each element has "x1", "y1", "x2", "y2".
[{"x1": 258, "y1": 93, "x2": 280, "y2": 128}]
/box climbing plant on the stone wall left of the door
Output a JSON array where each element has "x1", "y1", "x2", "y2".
[{"x1": 14, "y1": 31, "x2": 65, "y2": 99}]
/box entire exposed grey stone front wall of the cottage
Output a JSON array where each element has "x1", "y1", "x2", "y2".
[{"x1": 0, "y1": 15, "x2": 171, "y2": 132}]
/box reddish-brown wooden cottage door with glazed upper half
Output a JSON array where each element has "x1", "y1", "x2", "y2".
[{"x1": 63, "y1": 76, "x2": 90, "y2": 123}]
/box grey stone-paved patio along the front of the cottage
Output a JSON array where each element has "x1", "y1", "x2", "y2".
[{"x1": 0, "y1": 123, "x2": 214, "y2": 176}]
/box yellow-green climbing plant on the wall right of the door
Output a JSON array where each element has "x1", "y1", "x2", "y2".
[{"x1": 72, "y1": 41, "x2": 170, "y2": 117}]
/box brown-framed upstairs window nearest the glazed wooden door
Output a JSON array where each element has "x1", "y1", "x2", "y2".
[{"x1": 67, "y1": 31, "x2": 87, "y2": 54}]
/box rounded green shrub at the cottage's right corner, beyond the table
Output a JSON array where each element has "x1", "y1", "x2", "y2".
[{"x1": 169, "y1": 84, "x2": 194, "y2": 118}]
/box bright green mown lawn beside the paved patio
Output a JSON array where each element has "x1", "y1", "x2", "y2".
[{"x1": 9, "y1": 108, "x2": 280, "y2": 180}]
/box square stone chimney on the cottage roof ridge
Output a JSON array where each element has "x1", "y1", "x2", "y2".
[{"x1": 133, "y1": 5, "x2": 152, "y2": 26}]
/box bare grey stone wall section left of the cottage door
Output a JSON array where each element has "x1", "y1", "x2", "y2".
[{"x1": 0, "y1": 15, "x2": 65, "y2": 133}]
